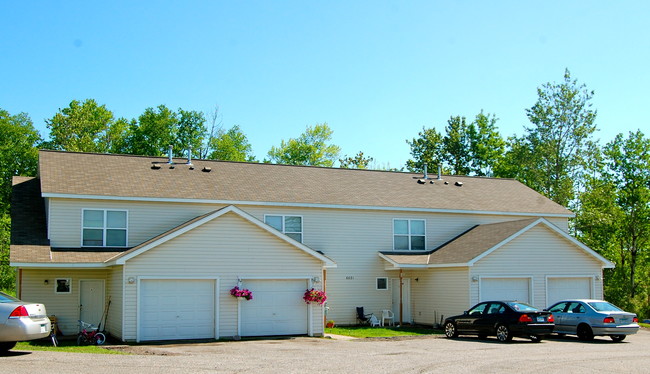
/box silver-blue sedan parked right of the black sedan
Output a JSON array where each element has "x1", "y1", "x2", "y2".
[{"x1": 546, "y1": 299, "x2": 639, "y2": 342}]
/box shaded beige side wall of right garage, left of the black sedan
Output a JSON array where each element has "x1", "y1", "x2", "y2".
[{"x1": 405, "y1": 267, "x2": 470, "y2": 326}]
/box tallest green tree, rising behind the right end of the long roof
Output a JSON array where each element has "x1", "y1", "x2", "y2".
[{"x1": 499, "y1": 70, "x2": 597, "y2": 206}]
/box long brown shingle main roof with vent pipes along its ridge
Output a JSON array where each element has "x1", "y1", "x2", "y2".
[{"x1": 39, "y1": 151, "x2": 572, "y2": 215}]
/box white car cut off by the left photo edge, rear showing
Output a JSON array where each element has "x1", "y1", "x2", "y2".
[{"x1": 0, "y1": 292, "x2": 52, "y2": 353}]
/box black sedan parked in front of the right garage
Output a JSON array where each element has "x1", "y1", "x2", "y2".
[{"x1": 444, "y1": 301, "x2": 555, "y2": 342}]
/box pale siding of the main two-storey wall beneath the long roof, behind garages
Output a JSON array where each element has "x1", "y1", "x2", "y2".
[{"x1": 50, "y1": 198, "x2": 567, "y2": 325}]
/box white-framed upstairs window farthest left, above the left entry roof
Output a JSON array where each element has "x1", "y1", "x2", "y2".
[{"x1": 81, "y1": 209, "x2": 128, "y2": 247}]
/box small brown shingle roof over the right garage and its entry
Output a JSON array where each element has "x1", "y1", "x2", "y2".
[{"x1": 382, "y1": 218, "x2": 536, "y2": 265}]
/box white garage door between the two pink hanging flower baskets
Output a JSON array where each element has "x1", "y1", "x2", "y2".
[{"x1": 240, "y1": 279, "x2": 308, "y2": 336}]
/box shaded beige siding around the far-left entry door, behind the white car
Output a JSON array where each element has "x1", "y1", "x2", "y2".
[{"x1": 20, "y1": 269, "x2": 109, "y2": 335}]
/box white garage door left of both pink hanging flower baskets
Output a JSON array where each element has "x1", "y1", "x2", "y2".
[{"x1": 138, "y1": 279, "x2": 215, "y2": 341}]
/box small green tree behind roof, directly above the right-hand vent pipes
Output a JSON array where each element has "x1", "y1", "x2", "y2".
[{"x1": 406, "y1": 128, "x2": 443, "y2": 173}]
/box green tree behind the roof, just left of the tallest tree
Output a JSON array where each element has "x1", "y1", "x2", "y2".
[{"x1": 467, "y1": 111, "x2": 506, "y2": 176}]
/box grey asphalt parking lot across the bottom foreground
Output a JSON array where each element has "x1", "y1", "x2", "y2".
[{"x1": 0, "y1": 330, "x2": 650, "y2": 374}]
